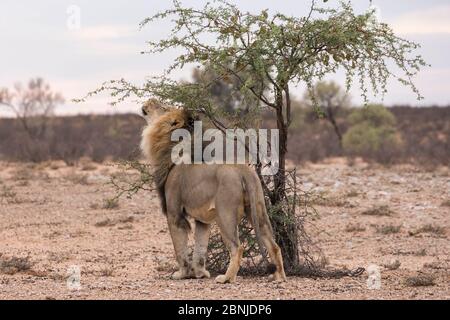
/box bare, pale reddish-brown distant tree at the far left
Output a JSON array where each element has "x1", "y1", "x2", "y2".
[{"x1": 0, "y1": 78, "x2": 64, "y2": 139}]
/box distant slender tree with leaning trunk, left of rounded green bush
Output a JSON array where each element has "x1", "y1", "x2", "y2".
[{"x1": 305, "y1": 81, "x2": 351, "y2": 147}]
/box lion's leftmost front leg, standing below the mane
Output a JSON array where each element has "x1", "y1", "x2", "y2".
[{"x1": 167, "y1": 214, "x2": 193, "y2": 280}]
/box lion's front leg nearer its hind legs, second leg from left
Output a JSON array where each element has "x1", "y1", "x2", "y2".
[{"x1": 193, "y1": 221, "x2": 211, "y2": 279}]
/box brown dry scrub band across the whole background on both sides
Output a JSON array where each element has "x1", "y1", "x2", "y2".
[{"x1": 0, "y1": 107, "x2": 450, "y2": 166}]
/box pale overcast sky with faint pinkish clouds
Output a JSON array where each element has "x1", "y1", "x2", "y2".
[{"x1": 0, "y1": 0, "x2": 450, "y2": 115}]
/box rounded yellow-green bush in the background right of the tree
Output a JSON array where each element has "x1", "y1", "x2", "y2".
[{"x1": 343, "y1": 105, "x2": 402, "y2": 163}]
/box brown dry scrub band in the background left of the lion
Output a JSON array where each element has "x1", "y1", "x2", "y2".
[{"x1": 0, "y1": 115, "x2": 145, "y2": 164}]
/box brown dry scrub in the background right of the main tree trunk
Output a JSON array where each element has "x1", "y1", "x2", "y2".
[{"x1": 282, "y1": 106, "x2": 450, "y2": 168}]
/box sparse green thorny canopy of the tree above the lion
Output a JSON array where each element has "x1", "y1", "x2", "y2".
[{"x1": 80, "y1": 0, "x2": 426, "y2": 115}]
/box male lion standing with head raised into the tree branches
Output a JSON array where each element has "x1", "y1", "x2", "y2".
[{"x1": 141, "y1": 100, "x2": 286, "y2": 283}]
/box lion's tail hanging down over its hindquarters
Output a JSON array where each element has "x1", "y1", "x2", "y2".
[{"x1": 243, "y1": 170, "x2": 267, "y2": 260}]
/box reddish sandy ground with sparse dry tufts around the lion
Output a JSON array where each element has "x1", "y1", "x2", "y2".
[{"x1": 0, "y1": 159, "x2": 450, "y2": 299}]
